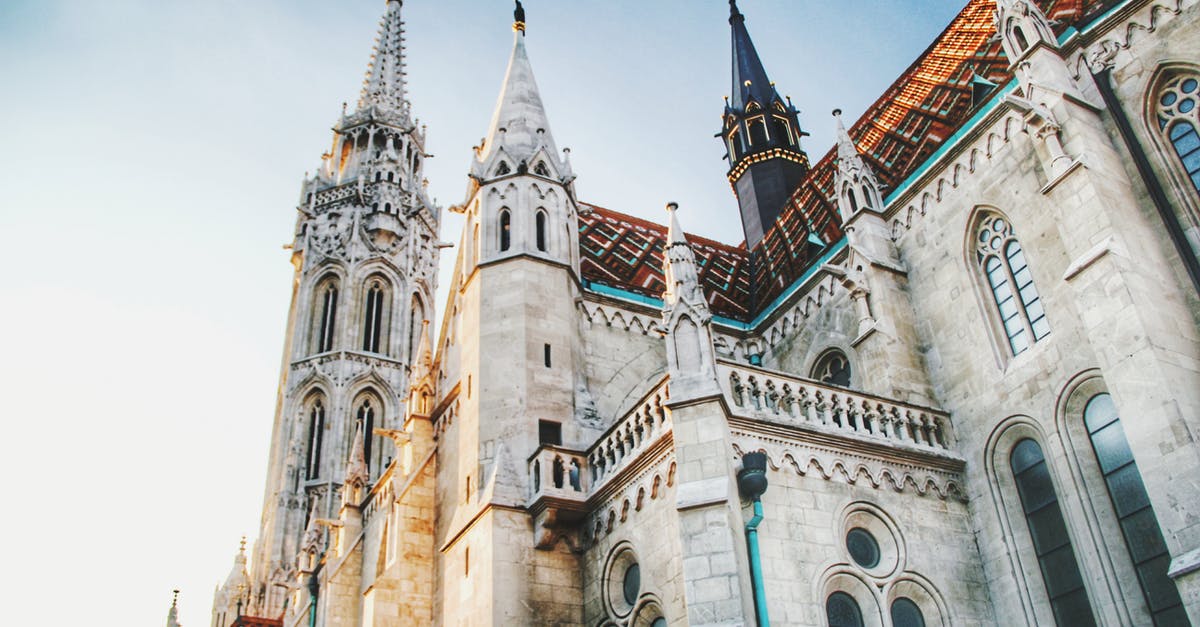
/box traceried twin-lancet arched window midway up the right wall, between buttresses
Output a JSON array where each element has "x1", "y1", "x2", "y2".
[{"x1": 976, "y1": 215, "x2": 1050, "y2": 356}]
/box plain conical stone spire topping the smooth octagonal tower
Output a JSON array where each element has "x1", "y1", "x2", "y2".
[{"x1": 476, "y1": 11, "x2": 562, "y2": 171}]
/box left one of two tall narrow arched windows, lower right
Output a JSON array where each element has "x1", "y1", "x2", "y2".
[{"x1": 1009, "y1": 438, "x2": 1096, "y2": 627}]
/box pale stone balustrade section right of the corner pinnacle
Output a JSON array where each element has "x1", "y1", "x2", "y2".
[{"x1": 718, "y1": 362, "x2": 953, "y2": 452}]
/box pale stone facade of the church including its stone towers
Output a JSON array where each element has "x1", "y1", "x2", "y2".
[{"x1": 214, "y1": 0, "x2": 1200, "y2": 627}]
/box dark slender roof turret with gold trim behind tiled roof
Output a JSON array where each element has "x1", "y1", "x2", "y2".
[{"x1": 720, "y1": 0, "x2": 809, "y2": 249}]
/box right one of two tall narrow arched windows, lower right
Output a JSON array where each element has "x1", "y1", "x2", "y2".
[{"x1": 1084, "y1": 394, "x2": 1188, "y2": 625}]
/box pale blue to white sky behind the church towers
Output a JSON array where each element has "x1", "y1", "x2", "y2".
[{"x1": 0, "y1": 0, "x2": 964, "y2": 627}]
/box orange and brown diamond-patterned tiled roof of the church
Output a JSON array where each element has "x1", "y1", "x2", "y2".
[{"x1": 580, "y1": 0, "x2": 1116, "y2": 321}]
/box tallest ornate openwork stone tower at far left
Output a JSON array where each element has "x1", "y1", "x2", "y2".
[{"x1": 214, "y1": 0, "x2": 440, "y2": 614}]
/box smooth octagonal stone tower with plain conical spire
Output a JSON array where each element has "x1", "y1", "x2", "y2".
[{"x1": 434, "y1": 2, "x2": 599, "y2": 625}]
